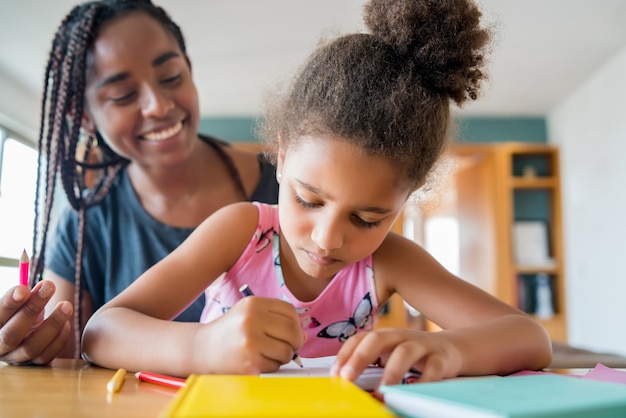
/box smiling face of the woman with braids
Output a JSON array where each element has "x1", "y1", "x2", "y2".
[{"x1": 83, "y1": 12, "x2": 199, "y2": 167}]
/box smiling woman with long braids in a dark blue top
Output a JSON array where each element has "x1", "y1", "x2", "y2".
[{"x1": 0, "y1": 0, "x2": 278, "y2": 363}]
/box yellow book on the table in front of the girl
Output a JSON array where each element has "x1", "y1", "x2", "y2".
[{"x1": 161, "y1": 375, "x2": 395, "y2": 418}]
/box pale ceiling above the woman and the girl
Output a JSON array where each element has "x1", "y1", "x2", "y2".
[{"x1": 0, "y1": 0, "x2": 626, "y2": 117}]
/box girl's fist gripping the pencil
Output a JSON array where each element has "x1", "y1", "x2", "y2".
[{"x1": 196, "y1": 296, "x2": 305, "y2": 375}]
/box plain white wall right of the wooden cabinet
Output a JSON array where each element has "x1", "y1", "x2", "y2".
[{"x1": 548, "y1": 43, "x2": 626, "y2": 355}]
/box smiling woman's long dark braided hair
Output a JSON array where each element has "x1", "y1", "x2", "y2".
[{"x1": 31, "y1": 0, "x2": 186, "y2": 357}]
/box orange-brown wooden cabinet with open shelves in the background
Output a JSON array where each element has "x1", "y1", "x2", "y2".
[{"x1": 452, "y1": 143, "x2": 567, "y2": 342}]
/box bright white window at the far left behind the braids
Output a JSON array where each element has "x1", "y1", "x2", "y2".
[{"x1": 0, "y1": 127, "x2": 37, "y2": 294}]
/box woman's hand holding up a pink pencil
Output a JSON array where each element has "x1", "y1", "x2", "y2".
[{"x1": 0, "y1": 280, "x2": 73, "y2": 364}]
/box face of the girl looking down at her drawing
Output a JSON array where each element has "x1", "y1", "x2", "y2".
[{"x1": 278, "y1": 137, "x2": 411, "y2": 280}]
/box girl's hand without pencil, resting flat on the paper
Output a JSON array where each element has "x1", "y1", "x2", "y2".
[{"x1": 331, "y1": 328, "x2": 462, "y2": 385}]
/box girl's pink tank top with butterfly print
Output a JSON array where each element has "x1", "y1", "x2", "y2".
[{"x1": 200, "y1": 202, "x2": 378, "y2": 357}]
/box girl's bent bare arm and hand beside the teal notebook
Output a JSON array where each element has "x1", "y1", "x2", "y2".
[{"x1": 334, "y1": 230, "x2": 552, "y2": 383}]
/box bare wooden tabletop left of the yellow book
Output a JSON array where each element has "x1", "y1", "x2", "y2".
[{"x1": 0, "y1": 359, "x2": 176, "y2": 418}]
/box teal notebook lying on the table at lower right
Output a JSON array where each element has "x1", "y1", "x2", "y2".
[{"x1": 380, "y1": 374, "x2": 626, "y2": 418}]
